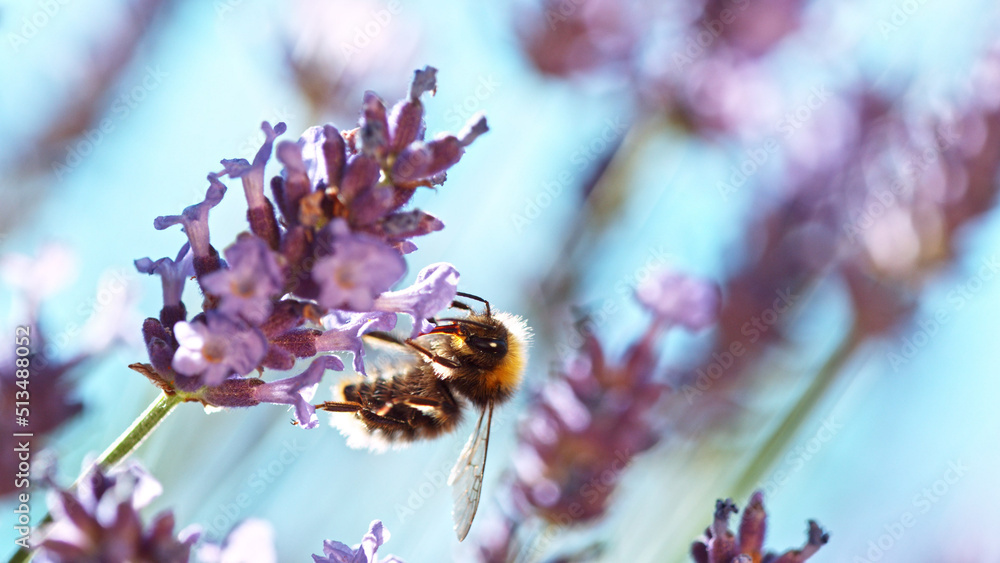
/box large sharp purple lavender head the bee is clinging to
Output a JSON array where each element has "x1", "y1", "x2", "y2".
[{"x1": 130, "y1": 67, "x2": 487, "y2": 428}]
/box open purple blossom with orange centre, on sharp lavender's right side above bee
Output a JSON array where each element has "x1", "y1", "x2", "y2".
[{"x1": 312, "y1": 220, "x2": 406, "y2": 311}]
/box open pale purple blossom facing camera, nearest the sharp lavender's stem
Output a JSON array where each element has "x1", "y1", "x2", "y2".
[{"x1": 172, "y1": 311, "x2": 267, "y2": 386}]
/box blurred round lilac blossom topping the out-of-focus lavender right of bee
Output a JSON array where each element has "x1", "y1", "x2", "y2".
[{"x1": 635, "y1": 270, "x2": 719, "y2": 330}]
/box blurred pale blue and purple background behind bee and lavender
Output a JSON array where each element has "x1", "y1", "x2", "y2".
[{"x1": 0, "y1": 0, "x2": 1000, "y2": 562}]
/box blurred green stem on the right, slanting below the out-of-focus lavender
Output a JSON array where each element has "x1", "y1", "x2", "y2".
[{"x1": 732, "y1": 330, "x2": 863, "y2": 498}]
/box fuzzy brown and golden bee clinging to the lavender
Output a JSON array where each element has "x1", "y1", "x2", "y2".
[{"x1": 316, "y1": 292, "x2": 530, "y2": 541}]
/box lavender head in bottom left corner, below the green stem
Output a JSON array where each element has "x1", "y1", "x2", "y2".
[{"x1": 35, "y1": 464, "x2": 198, "y2": 563}]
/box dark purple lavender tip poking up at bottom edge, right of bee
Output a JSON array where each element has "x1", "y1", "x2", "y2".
[{"x1": 691, "y1": 491, "x2": 830, "y2": 563}]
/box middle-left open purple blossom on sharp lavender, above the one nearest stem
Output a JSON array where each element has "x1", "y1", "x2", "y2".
[{"x1": 202, "y1": 235, "x2": 284, "y2": 326}]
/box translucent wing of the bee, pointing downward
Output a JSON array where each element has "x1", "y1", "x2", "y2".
[{"x1": 448, "y1": 404, "x2": 493, "y2": 541}]
